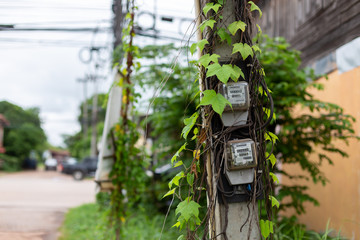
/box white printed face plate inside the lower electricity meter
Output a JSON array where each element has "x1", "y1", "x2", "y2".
[{"x1": 231, "y1": 142, "x2": 254, "y2": 166}]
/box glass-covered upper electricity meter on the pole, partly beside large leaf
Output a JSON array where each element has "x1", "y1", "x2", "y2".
[{"x1": 221, "y1": 81, "x2": 250, "y2": 111}]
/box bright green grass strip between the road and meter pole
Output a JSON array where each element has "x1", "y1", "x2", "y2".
[{"x1": 59, "y1": 203, "x2": 180, "y2": 240}]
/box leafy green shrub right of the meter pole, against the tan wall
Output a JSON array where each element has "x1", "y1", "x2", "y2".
[{"x1": 260, "y1": 36, "x2": 354, "y2": 214}]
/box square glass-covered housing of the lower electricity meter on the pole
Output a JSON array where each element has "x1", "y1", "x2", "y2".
[{"x1": 225, "y1": 139, "x2": 257, "y2": 171}]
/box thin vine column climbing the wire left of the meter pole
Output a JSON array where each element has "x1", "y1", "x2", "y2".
[{"x1": 110, "y1": 1, "x2": 145, "y2": 239}]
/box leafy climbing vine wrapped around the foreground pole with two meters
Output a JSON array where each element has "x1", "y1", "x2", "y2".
[{"x1": 164, "y1": 0, "x2": 279, "y2": 239}]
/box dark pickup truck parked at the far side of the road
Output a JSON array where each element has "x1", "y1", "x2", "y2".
[{"x1": 61, "y1": 157, "x2": 98, "y2": 180}]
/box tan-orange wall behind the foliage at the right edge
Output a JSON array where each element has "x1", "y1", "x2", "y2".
[{"x1": 282, "y1": 67, "x2": 360, "y2": 239}]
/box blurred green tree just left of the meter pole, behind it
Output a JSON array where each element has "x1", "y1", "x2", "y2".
[{"x1": 135, "y1": 44, "x2": 199, "y2": 163}]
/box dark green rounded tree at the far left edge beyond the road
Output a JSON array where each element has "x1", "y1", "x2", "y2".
[{"x1": 0, "y1": 101, "x2": 46, "y2": 170}]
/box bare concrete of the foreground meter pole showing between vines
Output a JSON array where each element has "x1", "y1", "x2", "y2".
[{"x1": 195, "y1": 0, "x2": 261, "y2": 240}]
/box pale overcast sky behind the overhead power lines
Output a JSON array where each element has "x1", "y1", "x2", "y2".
[{"x1": 0, "y1": 0, "x2": 194, "y2": 145}]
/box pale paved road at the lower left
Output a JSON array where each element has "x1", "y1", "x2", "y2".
[{"x1": 0, "y1": 171, "x2": 95, "y2": 240}]
